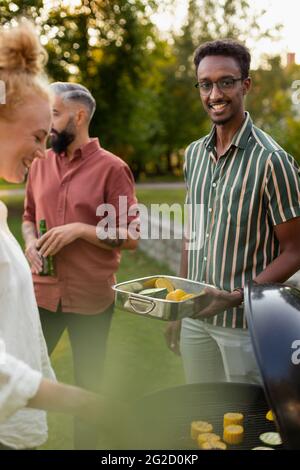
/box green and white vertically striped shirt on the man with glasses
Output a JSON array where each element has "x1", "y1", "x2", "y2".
[{"x1": 184, "y1": 113, "x2": 300, "y2": 328}]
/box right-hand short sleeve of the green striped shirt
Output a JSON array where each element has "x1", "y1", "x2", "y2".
[{"x1": 264, "y1": 151, "x2": 300, "y2": 225}]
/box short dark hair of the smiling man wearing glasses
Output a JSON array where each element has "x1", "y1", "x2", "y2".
[{"x1": 194, "y1": 39, "x2": 251, "y2": 79}]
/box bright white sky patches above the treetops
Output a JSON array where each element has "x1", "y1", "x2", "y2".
[{"x1": 152, "y1": 0, "x2": 300, "y2": 64}]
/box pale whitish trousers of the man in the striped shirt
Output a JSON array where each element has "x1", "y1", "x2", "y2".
[{"x1": 180, "y1": 318, "x2": 262, "y2": 384}]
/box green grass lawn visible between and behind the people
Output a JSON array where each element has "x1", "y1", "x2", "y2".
[{"x1": 5, "y1": 190, "x2": 184, "y2": 449}]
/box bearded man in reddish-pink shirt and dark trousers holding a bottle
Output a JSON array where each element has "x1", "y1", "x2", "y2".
[{"x1": 22, "y1": 82, "x2": 137, "y2": 449}]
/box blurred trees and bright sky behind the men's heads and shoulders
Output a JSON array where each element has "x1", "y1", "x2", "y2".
[{"x1": 0, "y1": 0, "x2": 300, "y2": 181}]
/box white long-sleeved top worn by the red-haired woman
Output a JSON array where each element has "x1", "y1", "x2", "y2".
[{"x1": 0, "y1": 201, "x2": 55, "y2": 449}]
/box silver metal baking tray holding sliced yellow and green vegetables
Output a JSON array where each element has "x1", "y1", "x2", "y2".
[{"x1": 113, "y1": 274, "x2": 213, "y2": 321}]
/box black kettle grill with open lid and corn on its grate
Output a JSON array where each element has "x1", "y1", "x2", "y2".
[{"x1": 132, "y1": 285, "x2": 300, "y2": 449}]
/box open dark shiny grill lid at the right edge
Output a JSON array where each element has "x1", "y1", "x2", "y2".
[{"x1": 245, "y1": 284, "x2": 300, "y2": 449}]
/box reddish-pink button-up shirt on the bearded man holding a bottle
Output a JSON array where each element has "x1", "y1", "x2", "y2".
[{"x1": 23, "y1": 139, "x2": 137, "y2": 314}]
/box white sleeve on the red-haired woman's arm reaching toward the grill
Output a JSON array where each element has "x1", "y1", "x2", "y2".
[{"x1": 0, "y1": 348, "x2": 42, "y2": 422}]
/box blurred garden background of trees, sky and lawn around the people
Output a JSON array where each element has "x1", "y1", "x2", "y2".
[{"x1": 0, "y1": 0, "x2": 300, "y2": 449}]
